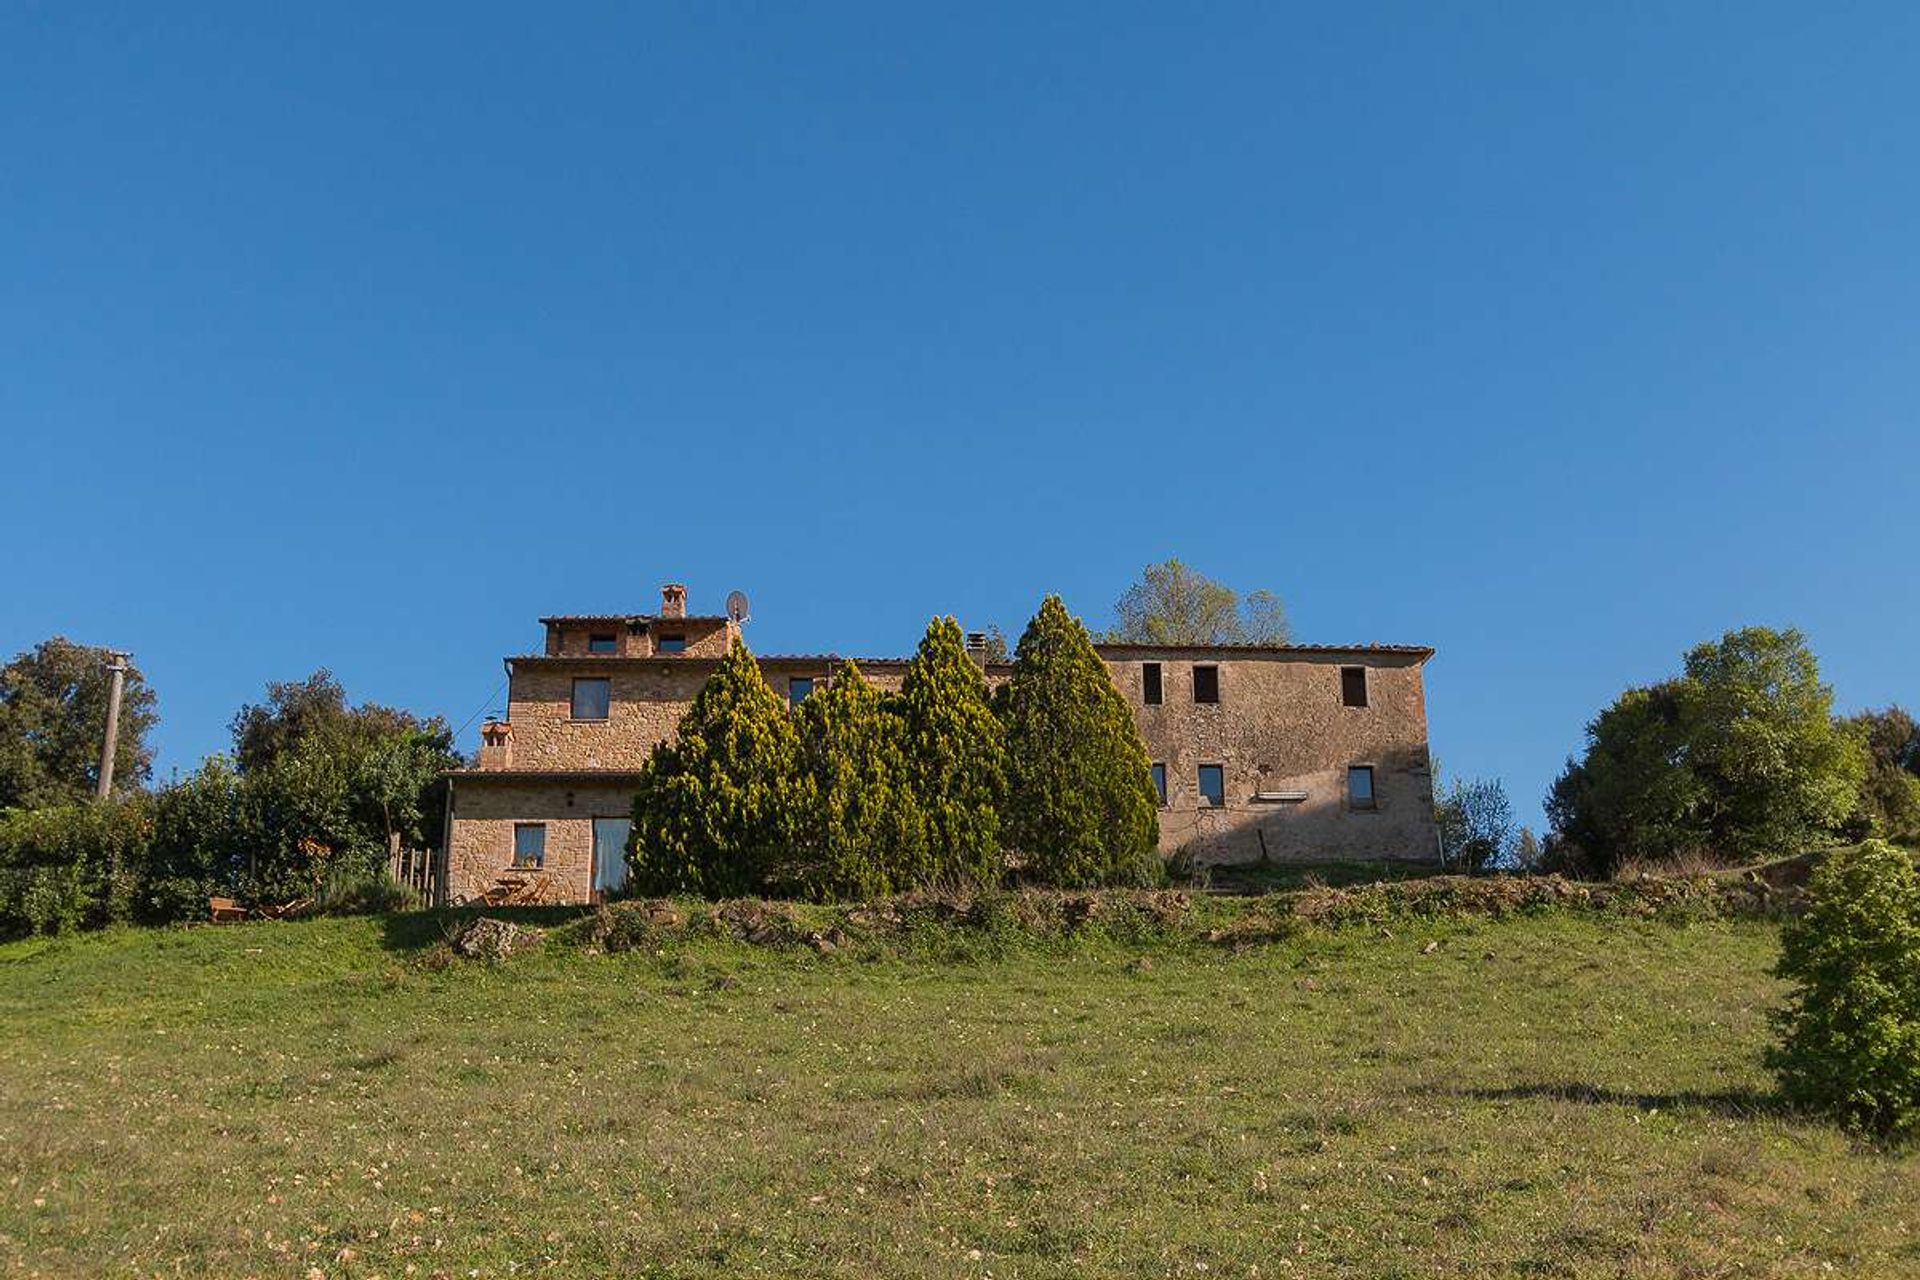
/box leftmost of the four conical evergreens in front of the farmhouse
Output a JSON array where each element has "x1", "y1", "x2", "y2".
[{"x1": 628, "y1": 641, "x2": 799, "y2": 898}]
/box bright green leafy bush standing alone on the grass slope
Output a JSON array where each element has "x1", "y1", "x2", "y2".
[{"x1": 1766, "y1": 841, "x2": 1920, "y2": 1138}]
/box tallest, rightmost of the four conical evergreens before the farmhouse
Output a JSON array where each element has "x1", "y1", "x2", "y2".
[{"x1": 996, "y1": 595, "x2": 1162, "y2": 887}]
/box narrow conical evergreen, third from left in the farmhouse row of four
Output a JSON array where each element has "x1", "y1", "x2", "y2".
[{"x1": 891, "y1": 618, "x2": 1006, "y2": 885}]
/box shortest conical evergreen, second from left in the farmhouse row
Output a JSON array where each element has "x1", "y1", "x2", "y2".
[{"x1": 781, "y1": 662, "x2": 931, "y2": 898}]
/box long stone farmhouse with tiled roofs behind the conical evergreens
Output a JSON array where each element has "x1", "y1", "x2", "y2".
[{"x1": 434, "y1": 583, "x2": 1438, "y2": 902}]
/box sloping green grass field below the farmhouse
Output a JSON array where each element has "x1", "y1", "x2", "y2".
[{"x1": 0, "y1": 913, "x2": 1920, "y2": 1278}]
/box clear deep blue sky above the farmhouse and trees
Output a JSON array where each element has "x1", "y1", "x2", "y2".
[{"x1": 0, "y1": 4, "x2": 1920, "y2": 832}]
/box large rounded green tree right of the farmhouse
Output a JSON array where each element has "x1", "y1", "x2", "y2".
[{"x1": 1548, "y1": 628, "x2": 1866, "y2": 875}]
